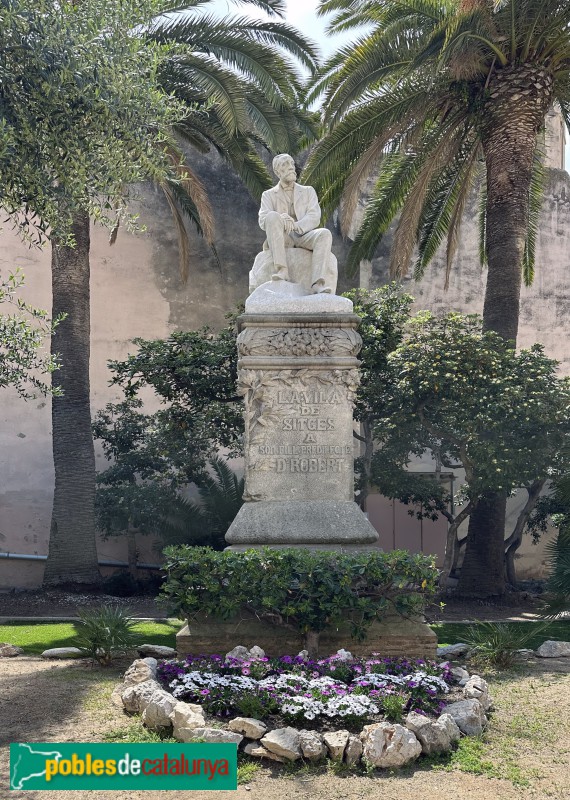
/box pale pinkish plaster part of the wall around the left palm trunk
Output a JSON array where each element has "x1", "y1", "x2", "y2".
[{"x1": 0, "y1": 217, "x2": 171, "y2": 587}]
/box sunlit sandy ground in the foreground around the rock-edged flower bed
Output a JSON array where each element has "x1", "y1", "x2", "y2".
[{"x1": 0, "y1": 657, "x2": 570, "y2": 800}]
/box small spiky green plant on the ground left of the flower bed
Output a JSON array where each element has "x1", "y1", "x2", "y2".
[{"x1": 74, "y1": 606, "x2": 136, "y2": 667}]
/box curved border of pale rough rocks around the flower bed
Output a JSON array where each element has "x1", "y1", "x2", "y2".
[{"x1": 113, "y1": 646, "x2": 492, "y2": 769}]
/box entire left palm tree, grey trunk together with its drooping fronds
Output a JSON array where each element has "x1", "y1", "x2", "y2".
[{"x1": 44, "y1": 0, "x2": 315, "y2": 585}]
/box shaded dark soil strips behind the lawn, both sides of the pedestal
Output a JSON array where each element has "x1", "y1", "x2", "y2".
[{"x1": 0, "y1": 590, "x2": 540, "y2": 622}]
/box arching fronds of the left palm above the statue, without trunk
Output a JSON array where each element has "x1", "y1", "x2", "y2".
[{"x1": 135, "y1": 0, "x2": 317, "y2": 280}]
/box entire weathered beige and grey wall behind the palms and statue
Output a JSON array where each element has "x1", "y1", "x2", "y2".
[{"x1": 0, "y1": 144, "x2": 570, "y2": 588}]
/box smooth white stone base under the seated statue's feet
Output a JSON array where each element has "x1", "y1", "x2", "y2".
[{"x1": 245, "y1": 280, "x2": 353, "y2": 314}]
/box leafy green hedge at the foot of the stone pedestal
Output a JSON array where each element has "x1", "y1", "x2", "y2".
[{"x1": 161, "y1": 545, "x2": 438, "y2": 652}]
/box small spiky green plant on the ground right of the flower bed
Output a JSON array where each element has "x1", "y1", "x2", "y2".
[{"x1": 465, "y1": 622, "x2": 540, "y2": 669}]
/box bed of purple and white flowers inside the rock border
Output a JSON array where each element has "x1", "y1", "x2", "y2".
[{"x1": 154, "y1": 656, "x2": 451, "y2": 726}]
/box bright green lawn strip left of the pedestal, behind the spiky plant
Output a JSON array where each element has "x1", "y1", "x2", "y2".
[{"x1": 0, "y1": 620, "x2": 182, "y2": 655}]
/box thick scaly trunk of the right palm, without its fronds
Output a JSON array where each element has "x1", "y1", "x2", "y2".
[{"x1": 458, "y1": 65, "x2": 552, "y2": 597}]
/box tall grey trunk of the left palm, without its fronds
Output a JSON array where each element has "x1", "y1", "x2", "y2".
[{"x1": 44, "y1": 213, "x2": 101, "y2": 586}]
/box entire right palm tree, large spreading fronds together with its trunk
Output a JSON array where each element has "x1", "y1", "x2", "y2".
[{"x1": 304, "y1": 0, "x2": 570, "y2": 595}]
